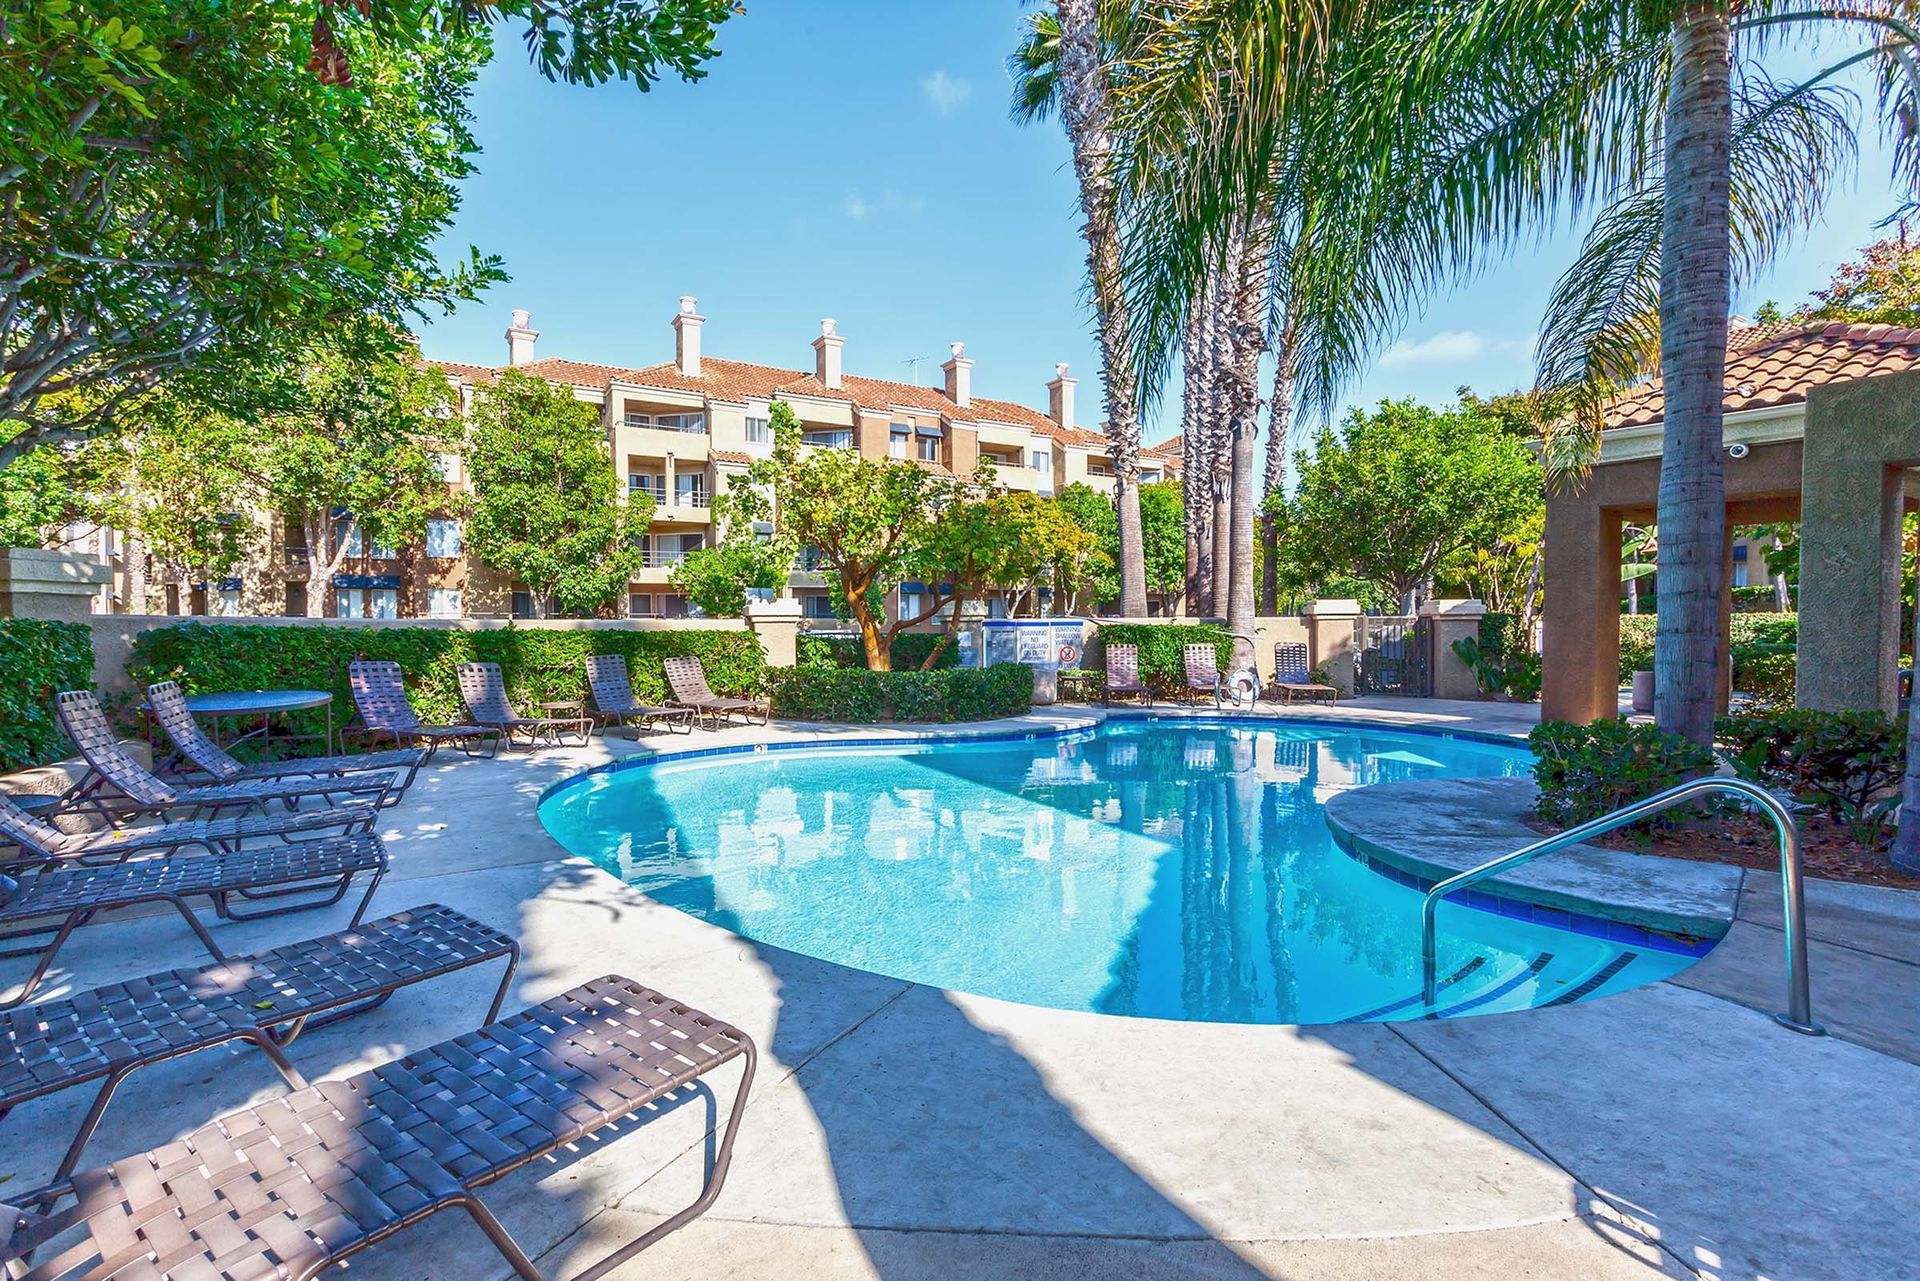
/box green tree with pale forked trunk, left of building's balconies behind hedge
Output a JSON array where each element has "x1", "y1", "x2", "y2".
[{"x1": 251, "y1": 321, "x2": 463, "y2": 618}]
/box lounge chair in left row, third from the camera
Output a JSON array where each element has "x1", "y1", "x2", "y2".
[{"x1": 0, "y1": 835, "x2": 386, "y2": 1008}]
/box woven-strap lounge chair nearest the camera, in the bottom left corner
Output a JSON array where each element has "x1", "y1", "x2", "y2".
[{"x1": 0, "y1": 976, "x2": 755, "y2": 1281}]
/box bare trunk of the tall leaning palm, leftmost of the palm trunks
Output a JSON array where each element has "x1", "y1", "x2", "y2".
[{"x1": 1054, "y1": 0, "x2": 1146, "y2": 618}]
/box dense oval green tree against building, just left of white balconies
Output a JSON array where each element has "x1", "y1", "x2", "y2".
[{"x1": 467, "y1": 371, "x2": 653, "y2": 615}]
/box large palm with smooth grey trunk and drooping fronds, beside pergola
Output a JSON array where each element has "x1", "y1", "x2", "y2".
[{"x1": 1121, "y1": 0, "x2": 1920, "y2": 741}]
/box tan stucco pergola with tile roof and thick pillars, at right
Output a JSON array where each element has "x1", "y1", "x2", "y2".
[{"x1": 1540, "y1": 325, "x2": 1920, "y2": 724}]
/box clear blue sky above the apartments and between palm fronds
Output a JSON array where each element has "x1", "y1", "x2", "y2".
[{"x1": 422, "y1": 0, "x2": 1893, "y2": 451}]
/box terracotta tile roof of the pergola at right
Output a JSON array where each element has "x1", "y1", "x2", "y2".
[{"x1": 1607, "y1": 323, "x2": 1920, "y2": 428}]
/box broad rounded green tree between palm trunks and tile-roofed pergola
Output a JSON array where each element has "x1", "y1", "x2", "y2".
[{"x1": 1273, "y1": 399, "x2": 1542, "y2": 611}]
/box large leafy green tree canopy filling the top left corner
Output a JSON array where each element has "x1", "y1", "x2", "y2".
[{"x1": 0, "y1": 0, "x2": 501, "y2": 465}]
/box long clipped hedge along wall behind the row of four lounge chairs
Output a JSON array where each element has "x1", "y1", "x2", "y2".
[{"x1": 127, "y1": 622, "x2": 766, "y2": 741}]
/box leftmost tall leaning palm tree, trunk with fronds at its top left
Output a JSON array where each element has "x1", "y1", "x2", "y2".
[{"x1": 1008, "y1": 0, "x2": 1146, "y2": 618}]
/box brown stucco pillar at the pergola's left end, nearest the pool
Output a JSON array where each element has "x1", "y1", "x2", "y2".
[{"x1": 1540, "y1": 494, "x2": 1620, "y2": 724}]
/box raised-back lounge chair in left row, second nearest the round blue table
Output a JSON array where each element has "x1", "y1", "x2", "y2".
[{"x1": 54, "y1": 689, "x2": 394, "y2": 824}]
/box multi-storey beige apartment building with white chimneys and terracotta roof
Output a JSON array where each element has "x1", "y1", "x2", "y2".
[{"x1": 78, "y1": 298, "x2": 1179, "y2": 620}]
